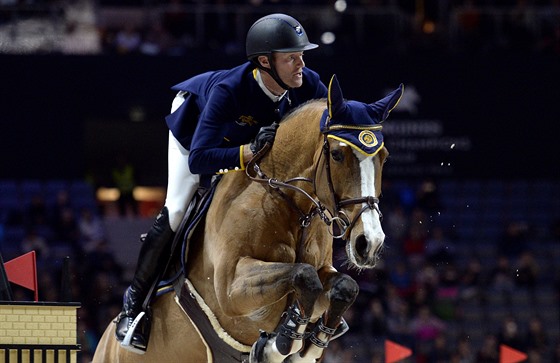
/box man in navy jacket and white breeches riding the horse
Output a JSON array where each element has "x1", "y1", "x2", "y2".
[{"x1": 116, "y1": 14, "x2": 327, "y2": 354}]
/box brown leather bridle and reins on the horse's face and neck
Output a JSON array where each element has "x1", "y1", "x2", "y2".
[{"x1": 245, "y1": 132, "x2": 383, "y2": 240}]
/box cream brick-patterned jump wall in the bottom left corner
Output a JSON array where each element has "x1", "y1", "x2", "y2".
[{"x1": 0, "y1": 301, "x2": 80, "y2": 363}]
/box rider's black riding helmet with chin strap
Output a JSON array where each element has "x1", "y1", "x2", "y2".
[{"x1": 245, "y1": 14, "x2": 318, "y2": 89}]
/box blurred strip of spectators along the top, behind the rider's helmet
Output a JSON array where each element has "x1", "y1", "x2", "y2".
[{"x1": 0, "y1": 0, "x2": 560, "y2": 56}]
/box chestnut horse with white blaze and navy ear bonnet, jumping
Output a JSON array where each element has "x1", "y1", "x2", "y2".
[{"x1": 93, "y1": 76, "x2": 403, "y2": 363}]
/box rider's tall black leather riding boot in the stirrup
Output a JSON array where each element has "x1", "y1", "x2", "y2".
[{"x1": 115, "y1": 207, "x2": 175, "y2": 354}]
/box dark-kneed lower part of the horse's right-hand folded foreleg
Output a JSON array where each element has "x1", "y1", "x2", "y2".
[{"x1": 286, "y1": 272, "x2": 359, "y2": 363}]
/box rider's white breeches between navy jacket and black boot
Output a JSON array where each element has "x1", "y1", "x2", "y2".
[{"x1": 165, "y1": 92, "x2": 200, "y2": 232}]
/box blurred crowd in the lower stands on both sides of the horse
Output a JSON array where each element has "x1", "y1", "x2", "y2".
[{"x1": 2, "y1": 181, "x2": 560, "y2": 363}]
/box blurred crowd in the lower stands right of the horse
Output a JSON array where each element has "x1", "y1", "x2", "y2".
[{"x1": 324, "y1": 181, "x2": 560, "y2": 363}]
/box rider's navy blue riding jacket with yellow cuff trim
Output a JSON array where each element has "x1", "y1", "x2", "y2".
[{"x1": 166, "y1": 62, "x2": 327, "y2": 179}]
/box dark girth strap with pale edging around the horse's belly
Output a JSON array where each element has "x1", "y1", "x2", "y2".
[{"x1": 179, "y1": 283, "x2": 249, "y2": 363}]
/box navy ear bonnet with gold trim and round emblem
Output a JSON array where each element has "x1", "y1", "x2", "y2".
[{"x1": 321, "y1": 76, "x2": 404, "y2": 156}]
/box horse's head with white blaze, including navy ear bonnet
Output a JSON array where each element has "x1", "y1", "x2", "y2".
[{"x1": 321, "y1": 76, "x2": 403, "y2": 268}]
